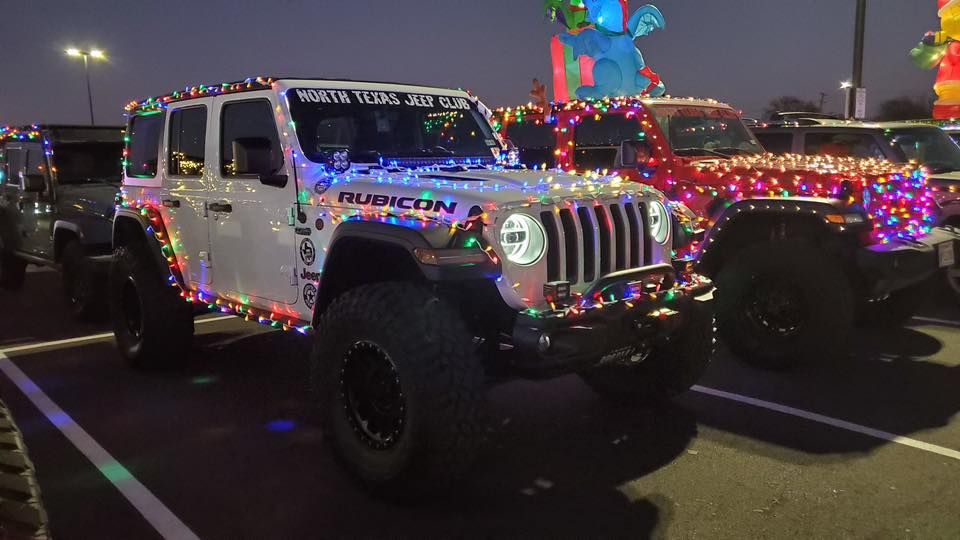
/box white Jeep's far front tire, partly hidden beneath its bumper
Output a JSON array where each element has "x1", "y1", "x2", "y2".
[{"x1": 580, "y1": 302, "x2": 716, "y2": 406}]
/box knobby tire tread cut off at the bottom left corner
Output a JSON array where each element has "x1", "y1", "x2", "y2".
[{"x1": 0, "y1": 401, "x2": 50, "y2": 538}]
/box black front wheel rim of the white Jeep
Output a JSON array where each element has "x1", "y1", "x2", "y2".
[{"x1": 340, "y1": 341, "x2": 406, "y2": 450}]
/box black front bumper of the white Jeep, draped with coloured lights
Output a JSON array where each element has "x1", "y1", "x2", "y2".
[{"x1": 511, "y1": 265, "x2": 714, "y2": 378}]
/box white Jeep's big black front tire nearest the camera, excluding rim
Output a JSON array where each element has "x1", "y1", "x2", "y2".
[{"x1": 311, "y1": 283, "x2": 485, "y2": 498}]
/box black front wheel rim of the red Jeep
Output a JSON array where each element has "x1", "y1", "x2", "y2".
[{"x1": 747, "y1": 275, "x2": 809, "y2": 338}]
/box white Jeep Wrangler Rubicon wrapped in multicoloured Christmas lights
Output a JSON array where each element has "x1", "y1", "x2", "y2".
[{"x1": 109, "y1": 78, "x2": 713, "y2": 493}]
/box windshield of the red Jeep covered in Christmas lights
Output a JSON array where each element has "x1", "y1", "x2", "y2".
[{"x1": 652, "y1": 105, "x2": 763, "y2": 157}]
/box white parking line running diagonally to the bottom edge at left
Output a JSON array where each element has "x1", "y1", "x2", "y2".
[{"x1": 0, "y1": 353, "x2": 199, "y2": 540}]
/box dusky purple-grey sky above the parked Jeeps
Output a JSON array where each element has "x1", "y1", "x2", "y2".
[{"x1": 0, "y1": 0, "x2": 938, "y2": 125}]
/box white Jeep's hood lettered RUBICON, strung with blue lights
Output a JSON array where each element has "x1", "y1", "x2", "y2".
[{"x1": 301, "y1": 165, "x2": 663, "y2": 220}]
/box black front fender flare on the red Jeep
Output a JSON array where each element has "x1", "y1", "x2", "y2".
[{"x1": 697, "y1": 197, "x2": 856, "y2": 275}]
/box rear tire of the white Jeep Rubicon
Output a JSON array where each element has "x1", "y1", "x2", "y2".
[{"x1": 108, "y1": 244, "x2": 194, "y2": 369}]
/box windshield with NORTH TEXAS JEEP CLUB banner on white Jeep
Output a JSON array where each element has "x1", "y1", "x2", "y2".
[{"x1": 287, "y1": 89, "x2": 499, "y2": 163}]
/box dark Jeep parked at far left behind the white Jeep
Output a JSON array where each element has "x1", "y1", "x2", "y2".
[{"x1": 0, "y1": 125, "x2": 123, "y2": 317}]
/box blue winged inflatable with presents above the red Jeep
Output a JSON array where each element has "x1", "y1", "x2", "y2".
[{"x1": 546, "y1": 0, "x2": 666, "y2": 102}]
